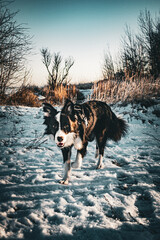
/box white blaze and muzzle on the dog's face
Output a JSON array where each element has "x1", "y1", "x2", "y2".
[{"x1": 55, "y1": 112, "x2": 75, "y2": 148}]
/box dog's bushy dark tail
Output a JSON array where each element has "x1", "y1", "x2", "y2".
[{"x1": 109, "y1": 112, "x2": 128, "y2": 142}]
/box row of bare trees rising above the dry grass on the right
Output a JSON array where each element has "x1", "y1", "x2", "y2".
[{"x1": 103, "y1": 9, "x2": 160, "y2": 80}]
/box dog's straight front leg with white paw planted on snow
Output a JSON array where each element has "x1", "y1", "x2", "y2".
[{"x1": 60, "y1": 147, "x2": 71, "y2": 185}]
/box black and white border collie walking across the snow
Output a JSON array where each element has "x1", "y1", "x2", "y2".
[{"x1": 43, "y1": 99, "x2": 127, "y2": 184}]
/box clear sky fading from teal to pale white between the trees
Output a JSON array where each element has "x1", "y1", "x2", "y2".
[{"x1": 11, "y1": 0, "x2": 160, "y2": 85}]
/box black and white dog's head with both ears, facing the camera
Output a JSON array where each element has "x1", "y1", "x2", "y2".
[{"x1": 43, "y1": 99, "x2": 77, "y2": 148}]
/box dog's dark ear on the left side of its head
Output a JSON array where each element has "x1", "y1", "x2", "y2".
[{"x1": 43, "y1": 103, "x2": 58, "y2": 125}]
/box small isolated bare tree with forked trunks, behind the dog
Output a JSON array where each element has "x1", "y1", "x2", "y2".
[{"x1": 41, "y1": 48, "x2": 74, "y2": 89}]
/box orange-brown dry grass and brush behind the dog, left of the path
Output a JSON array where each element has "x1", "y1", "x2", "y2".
[{"x1": 0, "y1": 85, "x2": 83, "y2": 107}]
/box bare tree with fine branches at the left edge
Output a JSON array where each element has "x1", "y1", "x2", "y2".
[{"x1": 0, "y1": 0, "x2": 31, "y2": 97}]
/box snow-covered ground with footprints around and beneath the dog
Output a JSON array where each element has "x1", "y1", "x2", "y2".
[{"x1": 0, "y1": 99, "x2": 160, "y2": 240}]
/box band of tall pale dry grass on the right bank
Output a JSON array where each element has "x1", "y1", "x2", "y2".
[{"x1": 91, "y1": 78, "x2": 160, "y2": 103}]
